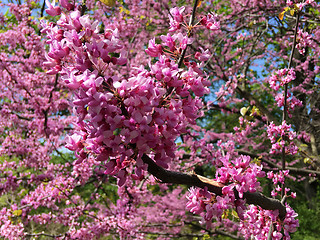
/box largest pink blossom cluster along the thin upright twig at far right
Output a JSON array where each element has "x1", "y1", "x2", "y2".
[{"x1": 267, "y1": 121, "x2": 298, "y2": 155}]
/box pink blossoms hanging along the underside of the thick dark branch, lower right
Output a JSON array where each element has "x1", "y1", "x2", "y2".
[{"x1": 186, "y1": 185, "x2": 299, "y2": 239}]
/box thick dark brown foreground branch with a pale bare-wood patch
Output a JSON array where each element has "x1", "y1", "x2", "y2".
[{"x1": 142, "y1": 154, "x2": 286, "y2": 219}]
